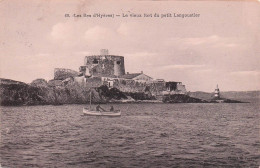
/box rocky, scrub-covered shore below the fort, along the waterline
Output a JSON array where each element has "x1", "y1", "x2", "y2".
[{"x1": 0, "y1": 78, "x2": 206, "y2": 106}]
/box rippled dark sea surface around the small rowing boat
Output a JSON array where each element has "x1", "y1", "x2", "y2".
[{"x1": 0, "y1": 103, "x2": 260, "y2": 167}]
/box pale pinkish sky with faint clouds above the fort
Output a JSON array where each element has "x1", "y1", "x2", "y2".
[{"x1": 0, "y1": 0, "x2": 260, "y2": 92}]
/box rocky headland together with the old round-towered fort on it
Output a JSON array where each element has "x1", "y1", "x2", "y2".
[{"x1": 0, "y1": 49, "x2": 244, "y2": 106}]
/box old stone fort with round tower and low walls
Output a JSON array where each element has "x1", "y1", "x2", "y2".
[{"x1": 54, "y1": 49, "x2": 187, "y2": 96}]
